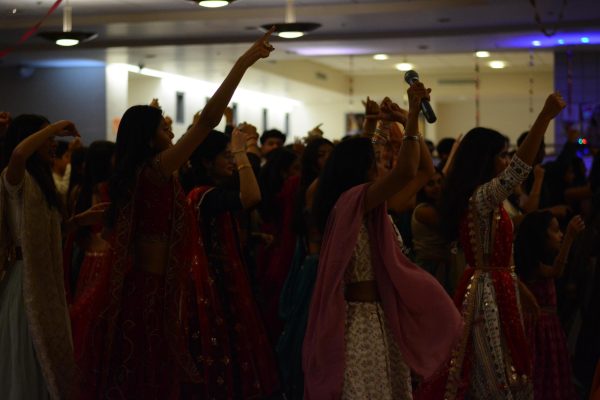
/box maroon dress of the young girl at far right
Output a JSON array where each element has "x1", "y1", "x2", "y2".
[{"x1": 527, "y1": 278, "x2": 576, "y2": 400}]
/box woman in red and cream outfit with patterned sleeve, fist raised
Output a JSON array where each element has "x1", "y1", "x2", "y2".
[{"x1": 434, "y1": 94, "x2": 565, "y2": 400}]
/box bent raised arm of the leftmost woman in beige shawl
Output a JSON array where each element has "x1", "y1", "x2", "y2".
[{"x1": 6, "y1": 121, "x2": 79, "y2": 186}]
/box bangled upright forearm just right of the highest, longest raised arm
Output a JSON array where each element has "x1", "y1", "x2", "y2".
[{"x1": 231, "y1": 129, "x2": 261, "y2": 209}]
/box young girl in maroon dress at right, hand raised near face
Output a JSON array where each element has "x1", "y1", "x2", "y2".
[{"x1": 515, "y1": 211, "x2": 585, "y2": 400}]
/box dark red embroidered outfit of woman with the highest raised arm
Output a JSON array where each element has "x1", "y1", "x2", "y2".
[{"x1": 92, "y1": 167, "x2": 206, "y2": 399}]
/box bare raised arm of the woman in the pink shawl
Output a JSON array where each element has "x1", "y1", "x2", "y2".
[{"x1": 365, "y1": 82, "x2": 430, "y2": 212}]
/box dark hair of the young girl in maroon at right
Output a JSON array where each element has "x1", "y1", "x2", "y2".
[{"x1": 514, "y1": 211, "x2": 556, "y2": 281}]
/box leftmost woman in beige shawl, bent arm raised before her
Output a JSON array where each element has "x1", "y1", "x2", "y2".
[{"x1": 0, "y1": 115, "x2": 80, "y2": 400}]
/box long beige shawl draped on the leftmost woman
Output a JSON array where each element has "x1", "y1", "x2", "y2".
[{"x1": 0, "y1": 170, "x2": 75, "y2": 399}]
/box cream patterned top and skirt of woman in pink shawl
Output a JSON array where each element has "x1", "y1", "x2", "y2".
[{"x1": 342, "y1": 224, "x2": 412, "y2": 400}]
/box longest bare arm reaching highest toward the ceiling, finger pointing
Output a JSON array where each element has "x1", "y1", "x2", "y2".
[{"x1": 159, "y1": 29, "x2": 273, "y2": 176}]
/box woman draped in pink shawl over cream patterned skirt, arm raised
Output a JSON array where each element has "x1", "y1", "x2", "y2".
[{"x1": 303, "y1": 83, "x2": 461, "y2": 400}]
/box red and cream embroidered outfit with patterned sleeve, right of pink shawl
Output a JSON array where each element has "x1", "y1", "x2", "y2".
[{"x1": 444, "y1": 156, "x2": 533, "y2": 400}]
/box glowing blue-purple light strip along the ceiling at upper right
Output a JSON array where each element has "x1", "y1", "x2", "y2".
[{"x1": 496, "y1": 32, "x2": 600, "y2": 48}]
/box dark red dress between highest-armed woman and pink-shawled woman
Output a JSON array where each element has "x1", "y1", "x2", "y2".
[{"x1": 188, "y1": 186, "x2": 279, "y2": 399}]
